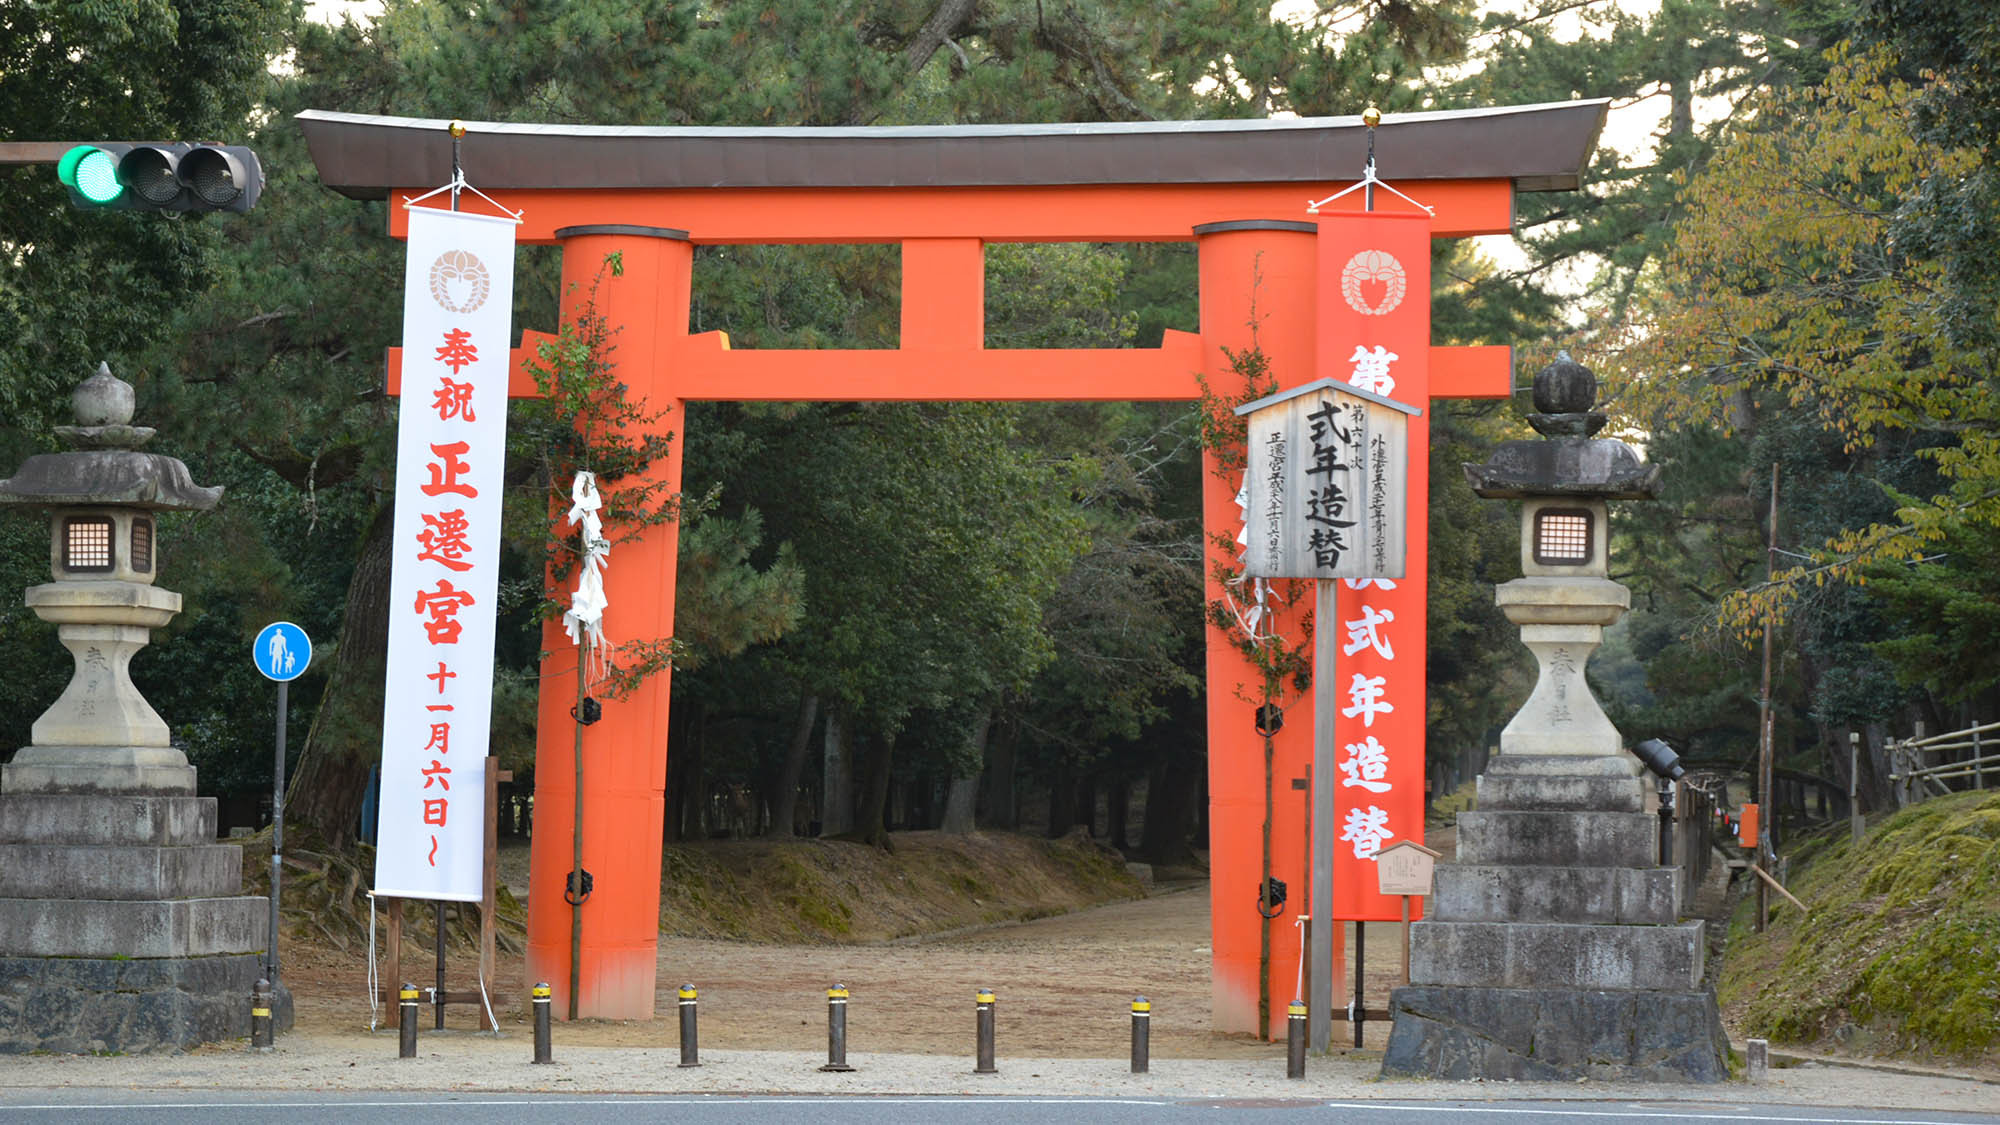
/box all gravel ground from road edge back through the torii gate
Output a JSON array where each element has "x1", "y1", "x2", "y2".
[{"x1": 0, "y1": 852, "x2": 2000, "y2": 1115}]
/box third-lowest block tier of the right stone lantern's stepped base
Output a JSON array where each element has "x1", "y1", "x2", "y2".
[{"x1": 1426, "y1": 863, "x2": 1680, "y2": 925}]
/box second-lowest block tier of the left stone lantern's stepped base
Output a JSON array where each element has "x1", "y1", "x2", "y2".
[{"x1": 0, "y1": 895, "x2": 270, "y2": 957}]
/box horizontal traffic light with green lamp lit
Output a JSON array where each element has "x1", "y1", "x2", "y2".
[{"x1": 56, "y1": 140, "x2": 264, "y2": 210}]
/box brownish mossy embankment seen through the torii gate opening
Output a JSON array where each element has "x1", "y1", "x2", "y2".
[{"x1": 660, "y1": 833, "x2": 1144, "y2": 943}]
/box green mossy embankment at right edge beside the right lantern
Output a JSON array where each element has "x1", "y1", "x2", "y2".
[{"x1": 1718, "y1": 793, "x2": 2000, "y2": 1067}]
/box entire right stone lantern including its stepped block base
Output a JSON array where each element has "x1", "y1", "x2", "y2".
[{"x1": 1382, "y1": 360, "x2": 1728, "y2": 1083}]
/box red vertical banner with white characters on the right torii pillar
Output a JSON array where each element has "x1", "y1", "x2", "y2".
[{"x1": 1314, "y1": 212, "x2": 1430, "y2": 921}]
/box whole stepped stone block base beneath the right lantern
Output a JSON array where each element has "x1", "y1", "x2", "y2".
[{"x1": 1382, "y1": 755, "x2": 1728, "y2": 1083}]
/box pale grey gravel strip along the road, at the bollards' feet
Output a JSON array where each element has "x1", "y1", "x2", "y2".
[{"x1": 0, "y1": 1029, "x2": 2000, "y2": 1113}]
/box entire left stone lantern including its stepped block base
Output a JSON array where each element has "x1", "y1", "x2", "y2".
[{"x1": 0, "y1": 368, "x2": 292, "y2": 1053}]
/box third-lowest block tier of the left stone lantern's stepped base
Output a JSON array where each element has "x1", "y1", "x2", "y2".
[{"x1": 0, "y1": 843, "x2": 244, "y2": 899}]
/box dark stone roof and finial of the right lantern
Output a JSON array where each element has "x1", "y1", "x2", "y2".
[{"x1": 1464, "y1": 352, "x2": 1660, "y2": 500}]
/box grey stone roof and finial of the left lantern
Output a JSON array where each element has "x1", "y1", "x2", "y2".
[{"x1": 0, "y1": 364, "x2": 222, "y2": 510}]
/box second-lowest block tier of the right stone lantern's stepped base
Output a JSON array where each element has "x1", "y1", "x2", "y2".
[{"x1": 1410, "y1": 921, "x2": 1702, "y2": 989}]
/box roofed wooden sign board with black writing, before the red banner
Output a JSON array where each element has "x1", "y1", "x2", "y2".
[{"x1": 1236, "y1": 378, "x2": 1420, "y2": 579}]
